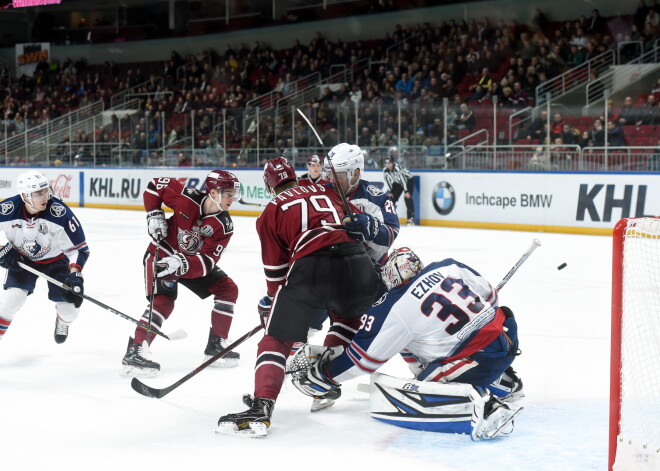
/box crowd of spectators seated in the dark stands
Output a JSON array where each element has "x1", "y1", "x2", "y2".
[{"x1": 0, "y1": 0, "x2": 660, "y2": 165}]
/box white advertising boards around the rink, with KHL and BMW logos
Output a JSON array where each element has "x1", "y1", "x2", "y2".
[{"x1": 0, "y1": 167, "x2": 660, "y2": 235}]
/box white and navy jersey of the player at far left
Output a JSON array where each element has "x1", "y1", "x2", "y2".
[{"x1": 0, "y1": 195, "x2": 89, "y2": 269}]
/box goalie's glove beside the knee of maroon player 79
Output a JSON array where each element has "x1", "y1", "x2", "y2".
[{"x1": 289, "y1": 345, "x2": 341, "y2": 399}]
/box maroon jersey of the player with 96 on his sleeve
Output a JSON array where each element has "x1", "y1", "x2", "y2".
[{"x1": 143, "y1": 177, "x2": 234, "y2": 278}]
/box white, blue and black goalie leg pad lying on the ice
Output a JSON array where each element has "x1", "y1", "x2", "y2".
[{"x1": 369, "y1": 373, "x2": 522, "y2": 441}]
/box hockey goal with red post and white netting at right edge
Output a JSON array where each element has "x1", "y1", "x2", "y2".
[{"x1": 608, "y1": 217, "x2": 660, "y2": 471}]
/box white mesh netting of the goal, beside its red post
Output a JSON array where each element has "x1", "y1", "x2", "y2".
[{"x1": 620, "y1": 218, "x2": 660, "y2": 449}]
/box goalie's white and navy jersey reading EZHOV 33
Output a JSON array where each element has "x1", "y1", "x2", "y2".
[{"x1": 327, "y1": 258, "x2": 504, "y2": 383}]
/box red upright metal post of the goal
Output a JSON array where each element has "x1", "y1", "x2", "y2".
[{"x1": 607, "y1": 218, "x2": 629, "y2": 471}]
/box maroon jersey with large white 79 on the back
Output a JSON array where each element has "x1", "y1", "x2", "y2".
[{"x1": 257, "y1": 185, "x2": 360, "y2": 296}]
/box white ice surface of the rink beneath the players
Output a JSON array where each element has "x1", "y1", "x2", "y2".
[{"x1": 0, "y1": 208, "x2": 611, "y2": 471}]
